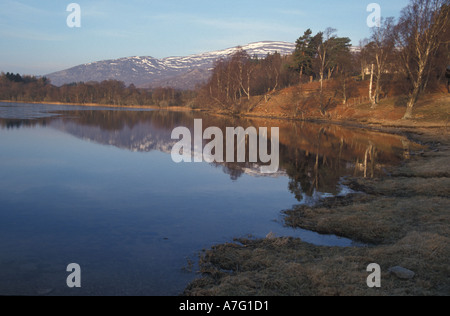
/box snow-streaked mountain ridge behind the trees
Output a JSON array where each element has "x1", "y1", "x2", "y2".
[{"x1": 46, "y1": 42, "x2": 295, "y2": 89}]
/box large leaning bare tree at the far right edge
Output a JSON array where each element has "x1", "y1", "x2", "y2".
[{"x1": 394, "y1": 0, "x2": 450, "y2": 119}]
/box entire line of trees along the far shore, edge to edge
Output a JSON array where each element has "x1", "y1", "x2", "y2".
[{"x1": 0, "y1": 0, "x2": 450, "y2": 119}]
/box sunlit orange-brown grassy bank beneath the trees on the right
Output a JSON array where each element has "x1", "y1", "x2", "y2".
[{"x1": 227, "y1": 91, "x2": 450, "y2": 128}]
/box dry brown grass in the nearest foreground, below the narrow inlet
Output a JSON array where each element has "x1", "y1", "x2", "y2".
[{"x1": 185, "y1": 232, "x2": 450, "y2": 296}]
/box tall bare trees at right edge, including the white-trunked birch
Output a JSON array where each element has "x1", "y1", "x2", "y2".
[{"x1": 359, "y1": 0, "x2": 450, "y2": 119}]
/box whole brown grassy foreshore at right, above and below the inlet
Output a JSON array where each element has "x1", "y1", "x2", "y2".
[{"x1": 184, "y1": 128, "x2": 450, "y2": 296}]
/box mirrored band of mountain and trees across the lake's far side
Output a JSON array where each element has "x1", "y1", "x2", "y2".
[{"x1": 0, "y1": 108, "x2": 411, "y2": 202}]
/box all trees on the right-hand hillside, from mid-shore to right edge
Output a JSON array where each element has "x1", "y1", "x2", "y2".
[{"x1": 197, "y1": 0, "x2": 450, "y2": 119}]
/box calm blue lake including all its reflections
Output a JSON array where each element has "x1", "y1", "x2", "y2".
[{"x1": 0, "y1": 103, "x2": 408, "y2": 295}]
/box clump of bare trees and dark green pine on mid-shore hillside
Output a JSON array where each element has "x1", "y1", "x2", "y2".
[{"x1": 197, "y1": 28, "x2": 358, "y2": 115}]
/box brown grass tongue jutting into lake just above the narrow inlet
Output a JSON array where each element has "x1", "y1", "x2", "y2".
[{"x1": 286, "y1": 195, "x2": 450, "y2": 244}]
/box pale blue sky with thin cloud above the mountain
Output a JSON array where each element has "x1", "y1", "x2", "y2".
[{"x1": 0, "y1": 0, "x2": 409, "y2": 76}]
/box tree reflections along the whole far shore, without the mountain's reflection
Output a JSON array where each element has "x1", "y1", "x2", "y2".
[{"x1": 53, "y1": 110, "x2": 404, "y2": 195}]
